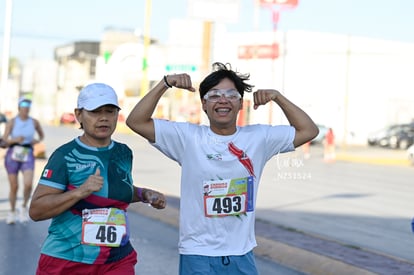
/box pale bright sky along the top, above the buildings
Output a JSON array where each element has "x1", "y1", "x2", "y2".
[{"x1": 0, "y1": 0, "x2": 414, "y2": 61}]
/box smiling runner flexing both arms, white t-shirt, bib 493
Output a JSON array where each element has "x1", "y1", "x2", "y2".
[{"x1": 126, "y1": 63, "x2": 319, "y2": 275}]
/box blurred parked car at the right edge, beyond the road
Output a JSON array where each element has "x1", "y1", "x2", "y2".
[{"x1": 368, "y1": 124, "x2": 414, "y2": 150}]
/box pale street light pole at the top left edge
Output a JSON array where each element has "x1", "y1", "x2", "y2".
[{"x1": 0, "y1": 0, "x2": 13, "y2": 110}]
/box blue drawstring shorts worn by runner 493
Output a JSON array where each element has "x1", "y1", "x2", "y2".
[{"x1": 179, "y1": 251, "x2": 259, "y2": 275}]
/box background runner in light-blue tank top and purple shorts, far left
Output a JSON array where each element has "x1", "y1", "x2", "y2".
[{"x1": 2, "y1": 98, "x2": 44, "y2": 224}]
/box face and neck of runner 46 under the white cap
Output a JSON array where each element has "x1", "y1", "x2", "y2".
[{"x1": 75, "y1": 105, "x2": 119, "y2": 147}]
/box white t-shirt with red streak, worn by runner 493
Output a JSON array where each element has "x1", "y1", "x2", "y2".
[{"x1": 152, "y1": 119, "x2": 295, "y2": 256}]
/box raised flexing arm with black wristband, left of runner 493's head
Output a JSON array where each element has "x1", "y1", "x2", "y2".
[{"x1": 126, "y1": 74, "x2": 195, "y2": 142}]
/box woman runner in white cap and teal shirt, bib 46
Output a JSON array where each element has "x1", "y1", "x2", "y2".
[{"x1": 29, "y1": 83, "x2": 166, "y2": 275}]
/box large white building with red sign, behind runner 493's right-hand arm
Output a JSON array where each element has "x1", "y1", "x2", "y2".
[{"x1": 212, "y1": 26, "x2": 414, "y2": 144}]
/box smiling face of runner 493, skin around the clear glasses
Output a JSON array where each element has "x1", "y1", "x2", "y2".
[{"x1": 202, "y1": 78, "x2": 243, "y2": 135}]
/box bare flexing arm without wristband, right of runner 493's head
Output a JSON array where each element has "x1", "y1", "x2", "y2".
[{"x1": 253, "y1": 90, "x2": 319, "y2": 147}]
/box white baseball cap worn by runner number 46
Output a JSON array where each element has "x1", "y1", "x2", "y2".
[{"x1": 78, "y1": 83, "x2": 121, "y2": 111}]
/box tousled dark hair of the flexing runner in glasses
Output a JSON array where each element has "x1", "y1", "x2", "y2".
[{"x1": 199, "y1": 62, "x2": 254, "y2": 99}]
